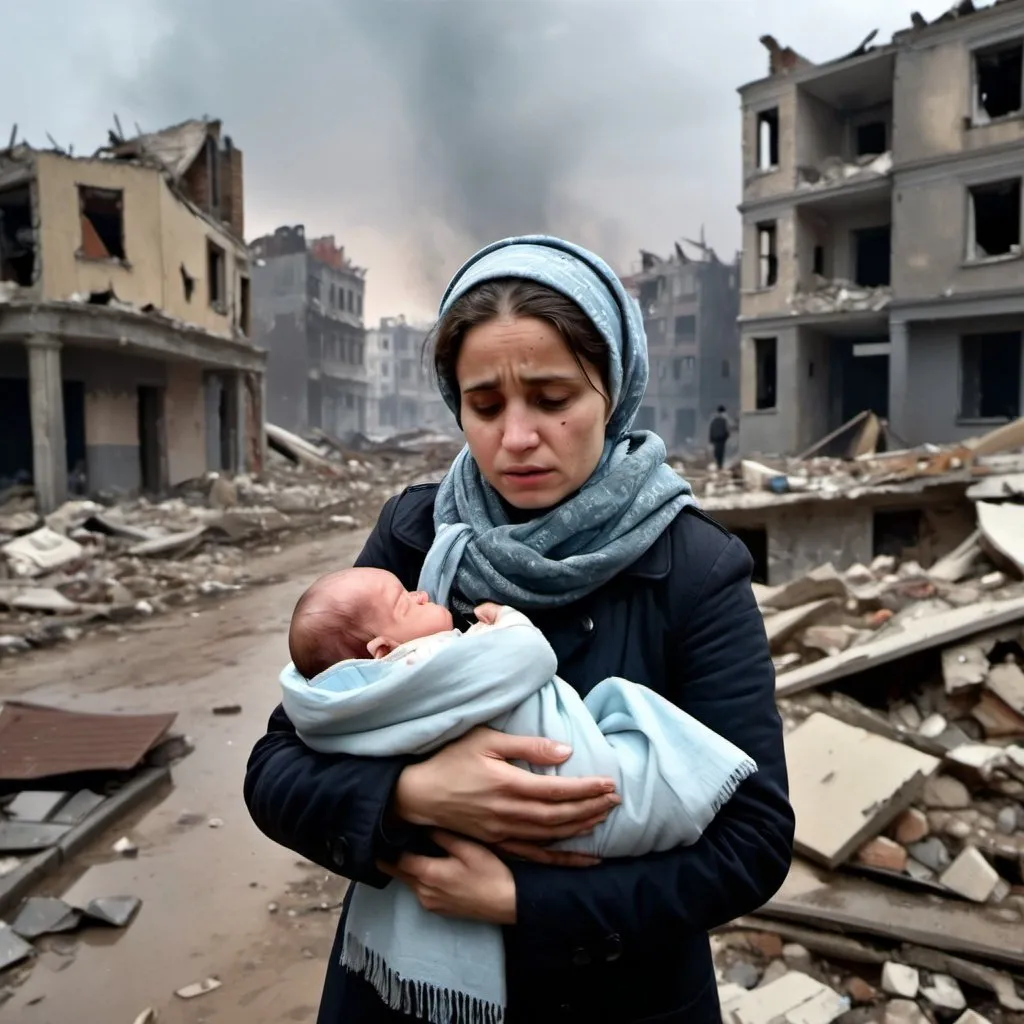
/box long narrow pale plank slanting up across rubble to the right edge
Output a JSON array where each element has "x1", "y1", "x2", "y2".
[{"x1": 775, "y1": 597, "x2": 1024, "y2": 697}]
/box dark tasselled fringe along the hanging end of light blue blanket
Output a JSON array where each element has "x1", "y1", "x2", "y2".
[{"x1": 340, "y1": 929, "x2": 505, "y2": 1024}]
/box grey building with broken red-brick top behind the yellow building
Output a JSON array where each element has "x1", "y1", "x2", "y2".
[{"x1": 250, "y1": 224, "x2": 369, "y2": 437}]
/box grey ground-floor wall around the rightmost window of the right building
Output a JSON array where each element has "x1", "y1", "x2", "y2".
[{"x1": 904, "y1": 316, "x2": 1024, "y2": 444}]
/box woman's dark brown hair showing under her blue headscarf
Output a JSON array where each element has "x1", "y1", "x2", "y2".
[{"x1": 427, "y1": 278, "x2": 610, "y2": 419}]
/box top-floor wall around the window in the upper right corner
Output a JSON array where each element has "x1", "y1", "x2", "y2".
[{"x1": 893, "y1": 20, "x2": 1024, "y2": 164}]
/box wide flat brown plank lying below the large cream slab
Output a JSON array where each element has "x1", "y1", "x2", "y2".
[{"x1": 758, "y1": 859, "x2": 1024, "y2": 969}]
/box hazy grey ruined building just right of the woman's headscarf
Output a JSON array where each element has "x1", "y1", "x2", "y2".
[{"x1": 625, "y1": 245, "x2": 739, "y2": 452}]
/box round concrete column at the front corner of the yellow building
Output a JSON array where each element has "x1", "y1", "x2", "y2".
[{"x1": 26, "y1": 335, "x2": 68, "y2": 514}]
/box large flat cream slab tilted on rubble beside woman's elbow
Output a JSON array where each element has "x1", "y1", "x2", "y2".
[{"x1": 785, "y1": 712, "x2": 941, "y2": 867}]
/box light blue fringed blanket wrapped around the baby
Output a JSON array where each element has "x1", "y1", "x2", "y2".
[{"x1": 281, "y1": 608, "x2": 757, "y2": 1024}]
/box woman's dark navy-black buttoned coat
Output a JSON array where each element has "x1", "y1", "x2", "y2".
[{"x1": 245, "y1": 484, "x2": 794, "y2": 1024}]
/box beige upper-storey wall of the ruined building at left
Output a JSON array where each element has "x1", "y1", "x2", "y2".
[{"x1": 37, "y1": 153, "x2": 245, "y2": 337}]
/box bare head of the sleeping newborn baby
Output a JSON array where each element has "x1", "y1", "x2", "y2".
[{"x1": 288, "y1": 568, "x2": 453, "y2": 679}]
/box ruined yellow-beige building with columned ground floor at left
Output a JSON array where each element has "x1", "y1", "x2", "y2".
[{"x1": 0, "y1": 120, "x2": 265, "y2": 510}]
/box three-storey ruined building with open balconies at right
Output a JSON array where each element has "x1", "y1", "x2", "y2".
[{"x1": 740, "y1": 0, "x2": 1024, "y2": 453}]
